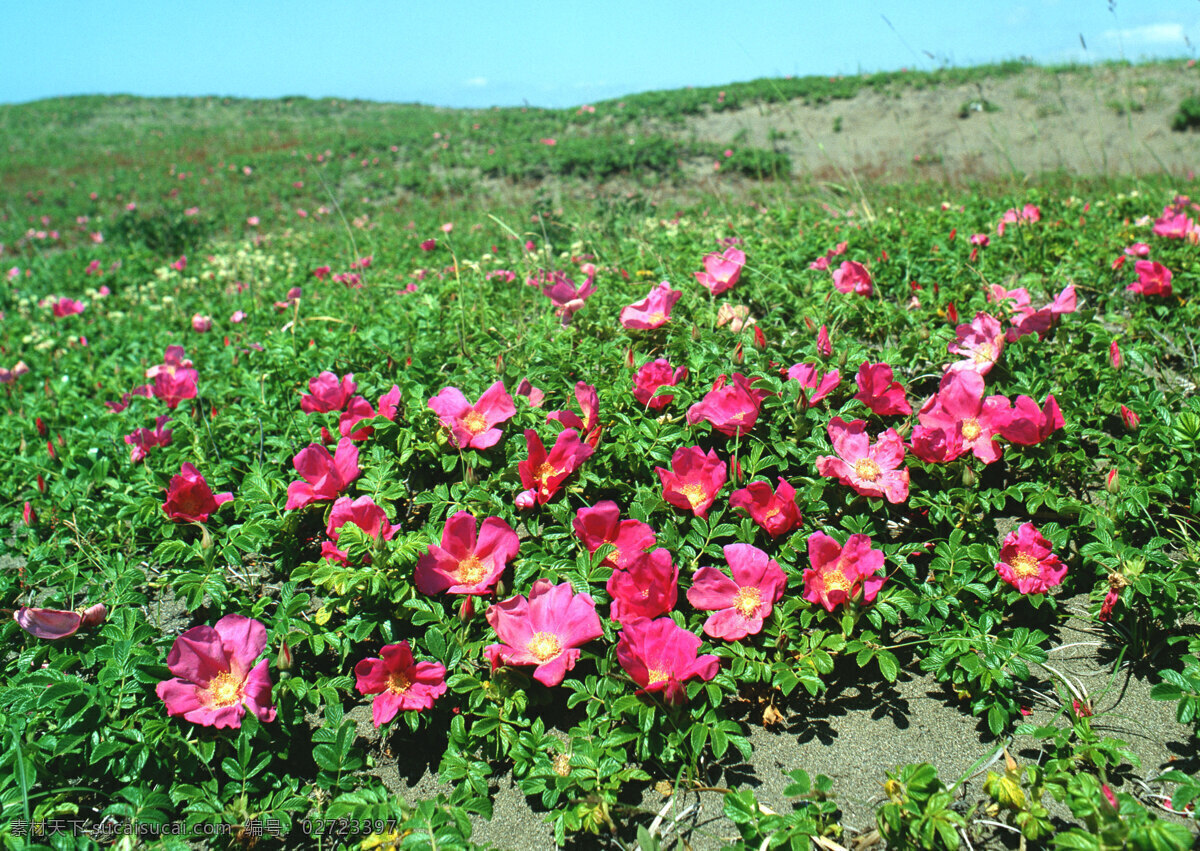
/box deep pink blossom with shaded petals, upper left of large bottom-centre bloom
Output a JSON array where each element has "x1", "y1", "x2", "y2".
[{"x1": 415, "y1": 511, "x2": 520, "y2": 595}]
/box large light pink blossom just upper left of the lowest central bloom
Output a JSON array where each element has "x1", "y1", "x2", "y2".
[{"x1": 484, "y1": 579, "x2": 604, "y2": 685}]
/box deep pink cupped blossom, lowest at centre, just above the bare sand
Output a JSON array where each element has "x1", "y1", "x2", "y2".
[{"x1": 617, "y1": 617, "x2": 721, "y2": 706}]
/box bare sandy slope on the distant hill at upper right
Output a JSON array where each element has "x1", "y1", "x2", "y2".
[{"x1": 684, "y1": 64, "x2": 1200, "y2": 180}]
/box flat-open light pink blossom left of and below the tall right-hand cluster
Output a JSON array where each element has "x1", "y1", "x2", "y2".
[{"x1": 817, "y1": 416, "x2": 908, "y2": 503}]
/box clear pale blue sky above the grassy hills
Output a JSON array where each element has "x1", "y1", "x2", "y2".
[{"x1": 0, "y1": 0, "x2": 1200, "y2": 107}]
